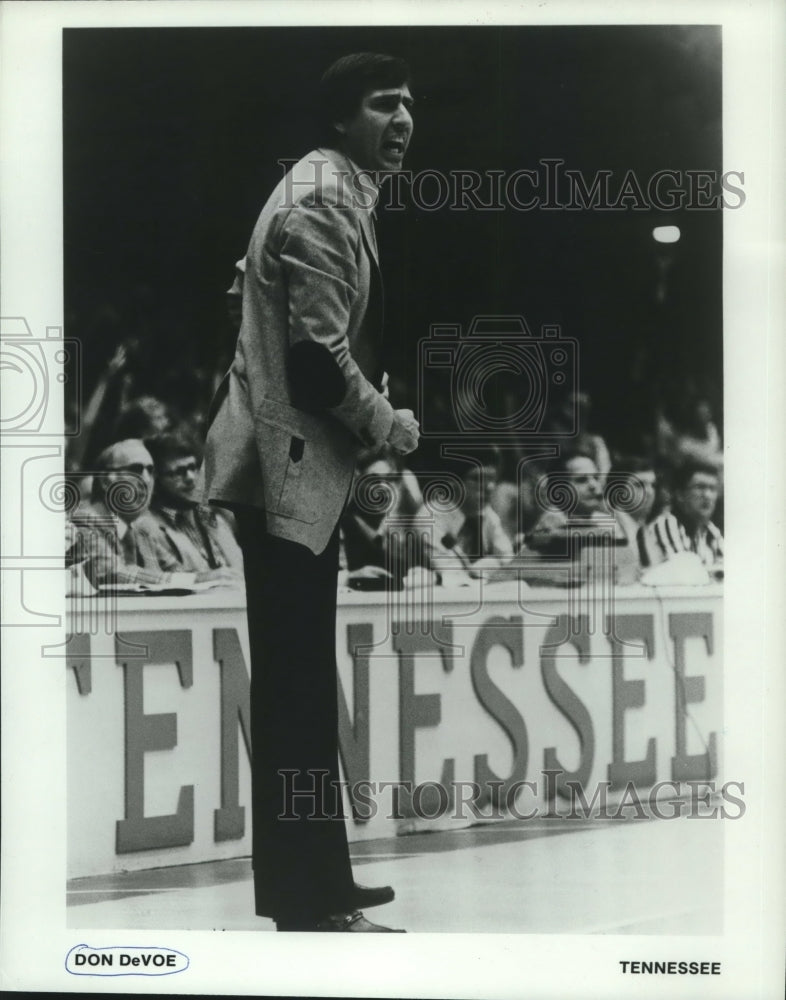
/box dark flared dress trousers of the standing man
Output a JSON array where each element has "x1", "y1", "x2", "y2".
[{"x1": 237, "y1": 509, "x2": 354, "y2": 922}]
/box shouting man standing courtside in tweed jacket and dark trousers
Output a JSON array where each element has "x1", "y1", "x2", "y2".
[{"x1": 203, "y1": 53, "x2": 418, "y2": 932}]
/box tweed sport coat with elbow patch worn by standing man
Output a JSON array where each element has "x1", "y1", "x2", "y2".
[{"x1": 202, "y1": 149, "x2": 393, "y2": 554}]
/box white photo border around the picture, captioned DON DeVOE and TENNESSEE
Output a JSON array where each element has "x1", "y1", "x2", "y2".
[{"x1": 0, "y1": 0, "x2": 786, "y2": 1000}]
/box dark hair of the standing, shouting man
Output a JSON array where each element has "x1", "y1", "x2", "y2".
[{"x1": 319, "y1": 52, "x2": 409, "y2": 140}]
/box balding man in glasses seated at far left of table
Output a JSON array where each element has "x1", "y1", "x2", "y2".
[{"x1": 66, "y1": 439, "x2": 235, "y2": 590}]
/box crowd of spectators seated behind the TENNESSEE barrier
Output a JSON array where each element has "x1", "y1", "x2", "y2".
[{"x1": 66, "y1": 304, "x2": 723, "y2": 593}]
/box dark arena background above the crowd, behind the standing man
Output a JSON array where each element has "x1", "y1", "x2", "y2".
[{"x1": 63, "y1": 26, "x2": 722, "y2": 458}]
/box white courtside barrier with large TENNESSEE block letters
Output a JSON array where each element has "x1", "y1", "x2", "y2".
[{"x1": 66, "y1": 582, "x2": 723, "y2": 877}]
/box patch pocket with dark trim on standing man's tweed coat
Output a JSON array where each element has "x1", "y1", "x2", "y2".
[{"x1": 255, "y1": 398, "x2": 319, "y2": 524}]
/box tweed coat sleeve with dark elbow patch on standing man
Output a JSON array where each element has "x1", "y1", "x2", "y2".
[{"x1": 281, "y1": 203, "x2": 393, "y2": 446}]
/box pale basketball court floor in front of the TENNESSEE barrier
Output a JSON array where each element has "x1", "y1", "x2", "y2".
[{"x1": 67, "y1": 817, "x2": 724, "y2": 935}]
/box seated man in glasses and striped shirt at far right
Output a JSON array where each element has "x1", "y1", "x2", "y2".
[{"x1": 644, "y1": 462, "x2": 723, "y2": 577}]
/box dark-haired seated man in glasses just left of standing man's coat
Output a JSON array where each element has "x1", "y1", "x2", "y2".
[{"x1": 145, "y1": 433, "x2": 243, "y2": 582}]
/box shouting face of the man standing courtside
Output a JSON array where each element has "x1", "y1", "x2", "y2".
[{"x1": 335, "y1": 84, "x2": 413, "y2": 170}]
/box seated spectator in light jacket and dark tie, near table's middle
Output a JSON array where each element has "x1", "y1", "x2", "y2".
[{"x1": 431, "y1": 461, "x2": 513, "y2": 578}]
